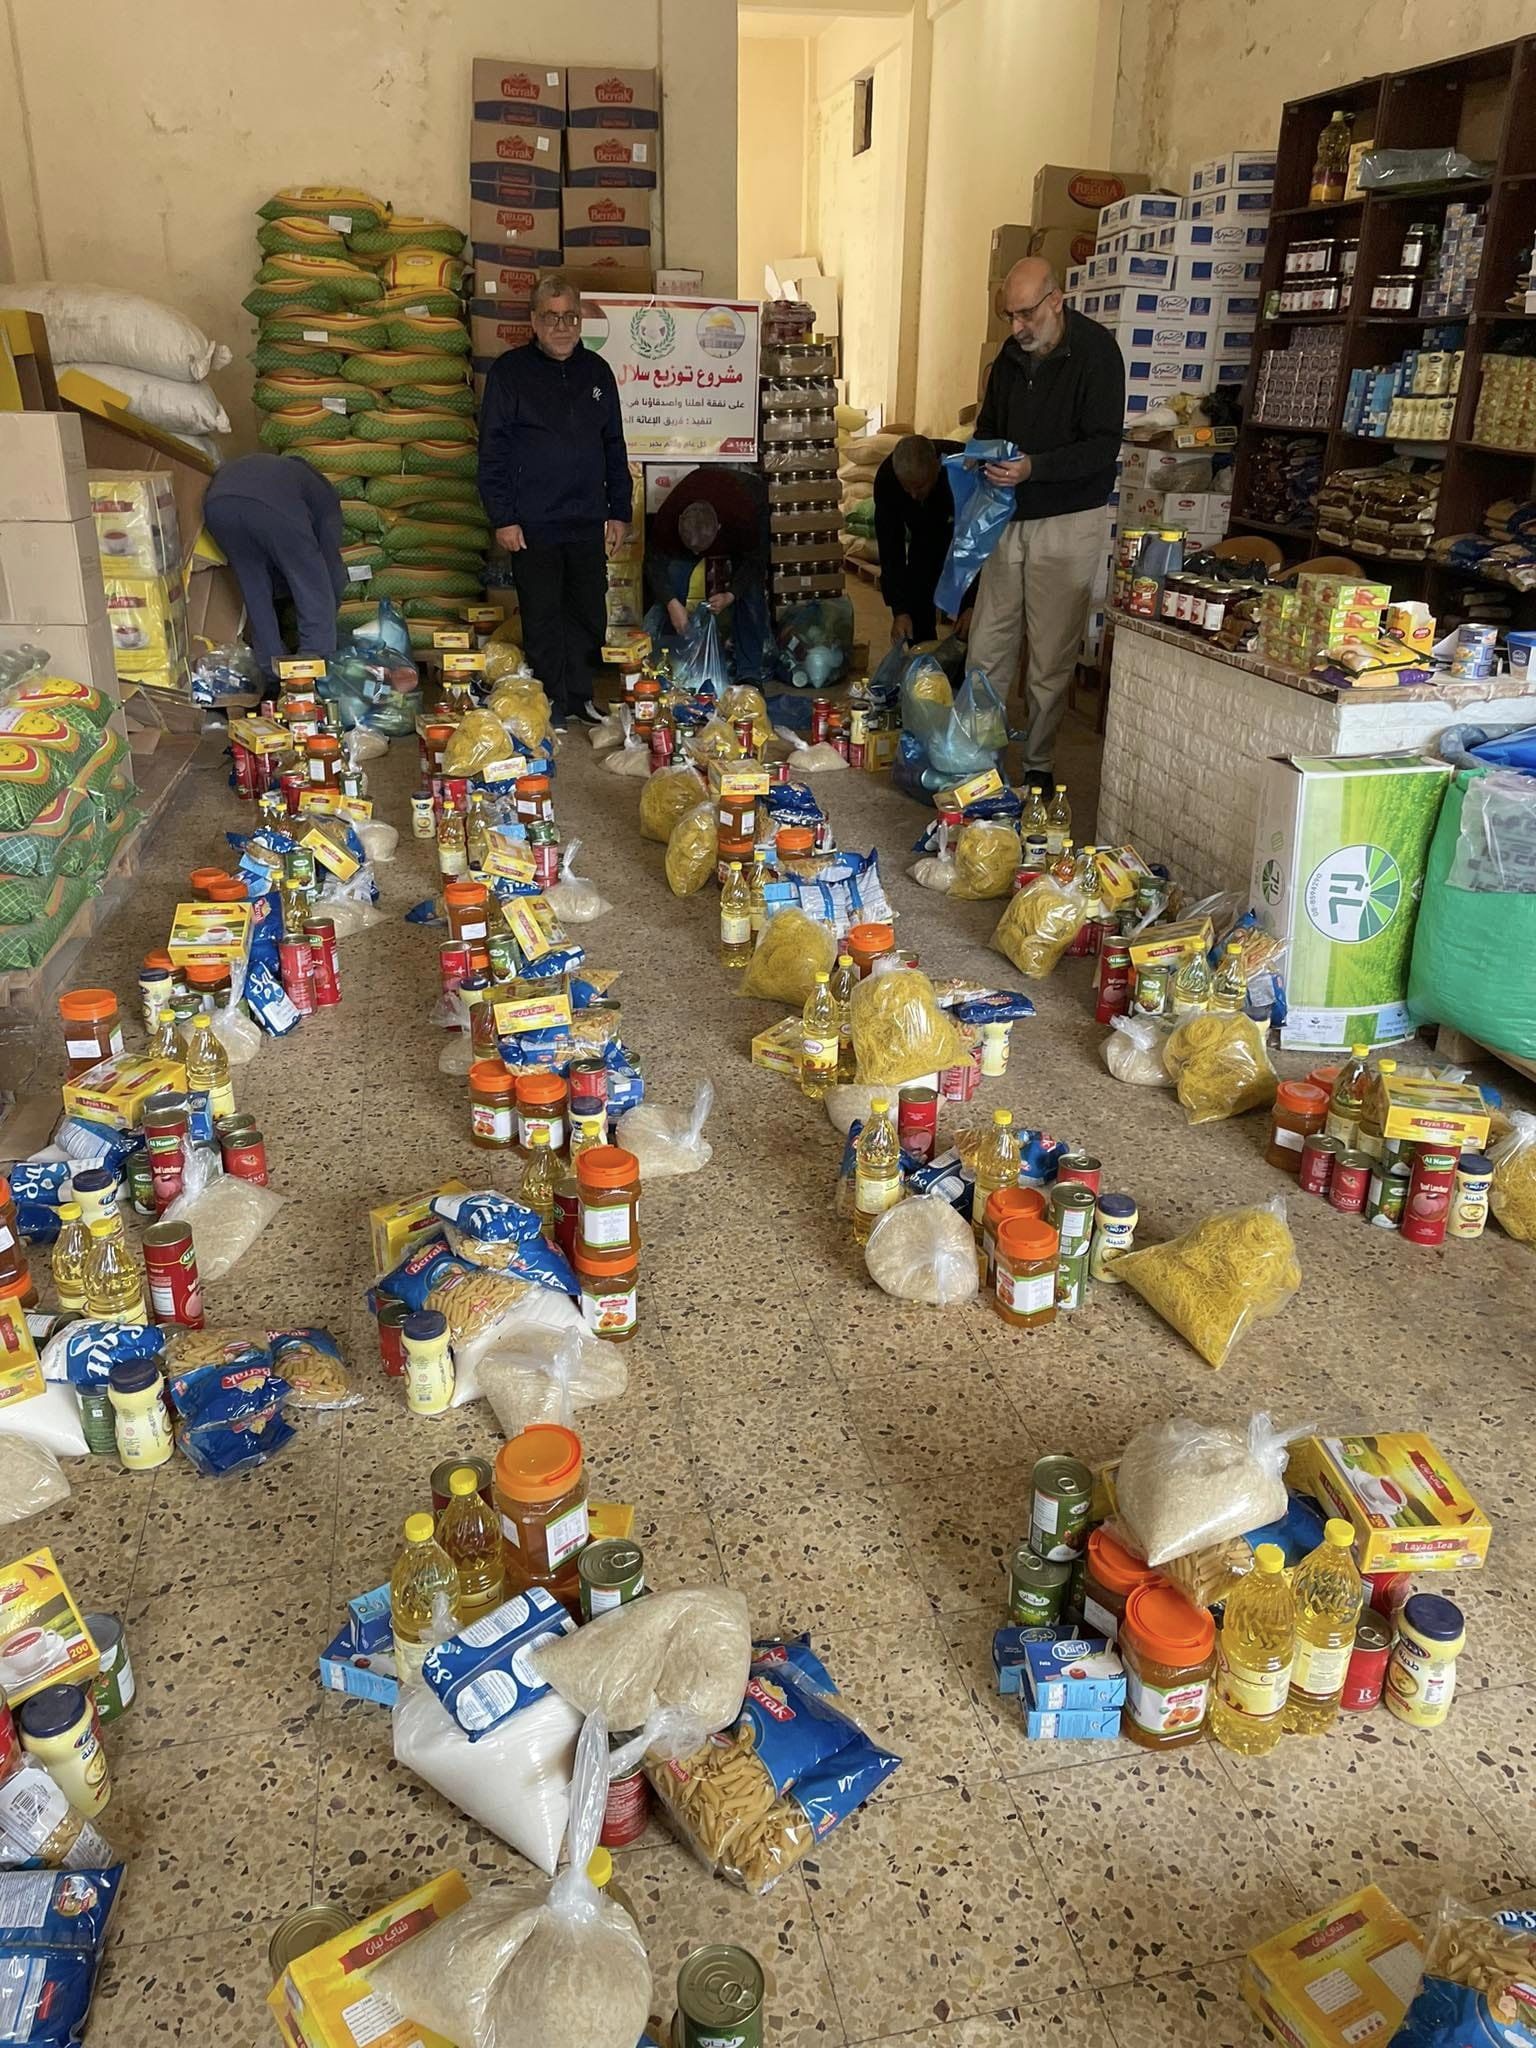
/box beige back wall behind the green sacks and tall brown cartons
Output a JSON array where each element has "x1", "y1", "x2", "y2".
[{"x1": 0, "y1": 0, "x2": 737, "y2": 444}]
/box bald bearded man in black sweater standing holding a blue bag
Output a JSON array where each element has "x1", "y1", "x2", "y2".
[{"x1": 971, "y1": 256, "x2": 1124, "y2": 786}]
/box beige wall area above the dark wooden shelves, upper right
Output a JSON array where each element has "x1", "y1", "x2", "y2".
[{"x1": 1114, "y1": 0, "x2": 1536, "y2": 188}]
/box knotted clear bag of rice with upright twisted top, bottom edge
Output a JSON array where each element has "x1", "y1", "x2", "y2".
[{"x1": 382, "y1": 1702, "x2": 651, "y2": 2048}]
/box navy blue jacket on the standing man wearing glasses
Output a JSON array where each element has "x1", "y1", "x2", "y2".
[{"x1": 479, "y1": 342, "x2": 631, "y2": 541}]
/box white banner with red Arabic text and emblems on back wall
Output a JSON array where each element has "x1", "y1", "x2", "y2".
[{"x1": 582, "y1": 293, "x2": 758, "y2": 463}]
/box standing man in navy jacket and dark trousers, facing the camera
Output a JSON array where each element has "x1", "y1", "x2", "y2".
[{"x1": 479, "y1": 274, "x2": 631, "y2": 725}]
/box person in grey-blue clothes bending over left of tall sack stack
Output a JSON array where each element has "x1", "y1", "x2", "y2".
[{"x1": 203, "y1": 455, "x2": 346, "y2": 676}]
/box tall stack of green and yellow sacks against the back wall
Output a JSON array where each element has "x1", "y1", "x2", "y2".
[{"x1": 244, "y1": 184, "x2": 489, "y2": 647}]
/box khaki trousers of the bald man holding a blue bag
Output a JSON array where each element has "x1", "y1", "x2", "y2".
[{"x1": 967, "y1": 506, "x2": 1106, "y2": 774}]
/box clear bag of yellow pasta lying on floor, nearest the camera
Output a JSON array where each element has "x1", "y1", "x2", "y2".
[{"x1": 1114, "y1": 1194, "x2": 1300, "y2": 1368}]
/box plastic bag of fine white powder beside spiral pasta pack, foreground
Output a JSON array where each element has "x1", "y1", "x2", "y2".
[{"x1": 393, "y1": 1683, "x2": 585, "y2": 1875}]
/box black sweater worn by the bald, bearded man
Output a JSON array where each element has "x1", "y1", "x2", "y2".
[{"x1": 975, "y1": 307, "x2": 1124, "y2": 518}]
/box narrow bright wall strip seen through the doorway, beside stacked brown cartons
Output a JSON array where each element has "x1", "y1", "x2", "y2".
[{"x1": 735, "y1": 34, "x2": 811, "y2": 299}]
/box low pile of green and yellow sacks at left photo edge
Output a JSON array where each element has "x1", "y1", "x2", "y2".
[{"x1": 0, "y1": 674, "x2": 137, "y2": 971}]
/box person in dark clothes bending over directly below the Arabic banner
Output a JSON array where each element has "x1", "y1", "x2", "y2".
[{"x1": 645, "y1": 465, "x2": 772, "y2": 682}]
